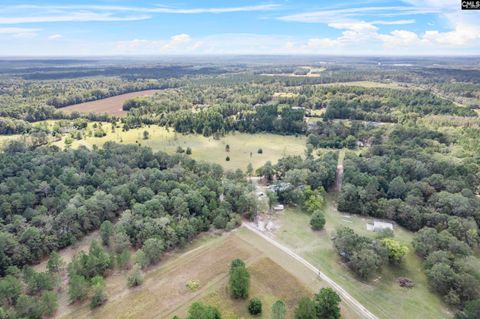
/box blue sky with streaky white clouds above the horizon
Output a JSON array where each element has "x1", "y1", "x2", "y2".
[{"x1": 0, "y1": 0, "x2": 480, "y2": 56}]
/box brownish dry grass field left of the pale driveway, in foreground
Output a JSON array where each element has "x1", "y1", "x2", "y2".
[{"x1": 59, "y1": 228, "x2": 359, "y2": 319}]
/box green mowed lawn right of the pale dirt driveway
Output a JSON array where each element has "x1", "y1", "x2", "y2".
[{"x1": 275, "y1": 198, "x2": 453, "y2": 319}]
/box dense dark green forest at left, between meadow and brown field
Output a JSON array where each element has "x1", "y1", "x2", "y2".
[{"x1": 0, "y1": 143, "x2": 256, "y2": 274}]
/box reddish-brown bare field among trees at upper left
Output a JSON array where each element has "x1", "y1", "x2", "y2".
[{"x1": 60, "y1": 90, "x2": 159, "y2": 116}]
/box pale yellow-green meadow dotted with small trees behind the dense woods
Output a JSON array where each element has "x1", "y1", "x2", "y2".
[{"x1": 56, "y1": 123, "x2": 305, "y2": 171}]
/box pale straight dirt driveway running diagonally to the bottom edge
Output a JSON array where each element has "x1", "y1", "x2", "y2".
[{"x1": 243, "y1": 222, "x2": 378, "y2": 319}]
